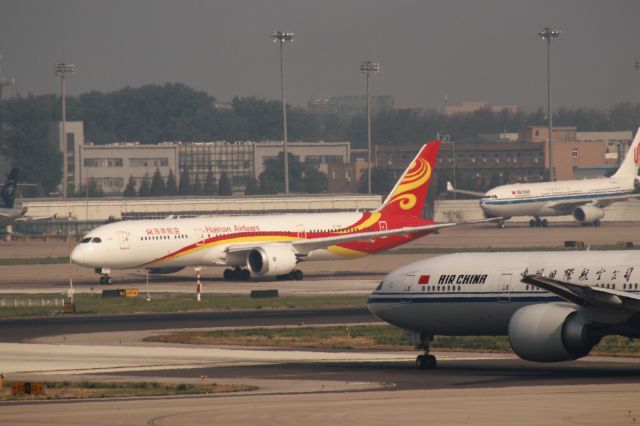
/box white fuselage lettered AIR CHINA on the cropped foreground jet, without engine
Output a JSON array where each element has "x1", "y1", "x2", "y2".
[{"x1": 369, "y1": 251, "x2": 640, "y2": 337}]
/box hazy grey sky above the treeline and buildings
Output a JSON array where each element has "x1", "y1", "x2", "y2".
[{"x1": 0, "y1": 0, "x2": 640, "y2": 110}]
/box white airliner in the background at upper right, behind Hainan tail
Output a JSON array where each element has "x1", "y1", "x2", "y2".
[{"x1": 447, "y1": 129, "x2": 640, "y2": 227}]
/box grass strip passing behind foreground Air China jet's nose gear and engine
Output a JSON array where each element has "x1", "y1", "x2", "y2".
[{"x1": 145, "y1": 325, "x2": 640, "y2": 356}]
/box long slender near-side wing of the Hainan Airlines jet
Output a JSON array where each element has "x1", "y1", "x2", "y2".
[{"x1": 226, "y1": 218, "x2": 502, "y2": 256}]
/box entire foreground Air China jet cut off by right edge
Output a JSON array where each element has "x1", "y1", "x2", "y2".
[{"x1": 368, "y1": 251, "x2": 640, "y2": 369}]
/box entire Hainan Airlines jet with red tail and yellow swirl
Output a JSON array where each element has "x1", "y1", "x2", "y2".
[{"x1": 71, "y1": 141, "x2": 488, "y2": 284}]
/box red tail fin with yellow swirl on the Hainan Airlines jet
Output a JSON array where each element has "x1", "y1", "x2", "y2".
[{"x1": 377, "y1": 141, "x2": 440, "y2": 217}]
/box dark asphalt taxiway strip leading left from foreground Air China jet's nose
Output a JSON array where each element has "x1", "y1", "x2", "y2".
[{"x1": 0, "y1": 307, "x2": 379, "y2": 343}]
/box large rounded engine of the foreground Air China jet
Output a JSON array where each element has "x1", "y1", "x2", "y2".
[{"x1": 509, "y1": 303, "x2": 602, "y2": 362}]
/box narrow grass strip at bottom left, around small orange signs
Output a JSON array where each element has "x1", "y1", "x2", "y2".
[{"x1": 0, "y1": 380, "x2": 257, "y2": 401}]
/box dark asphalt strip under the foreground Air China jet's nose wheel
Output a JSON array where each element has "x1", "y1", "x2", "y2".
[{"x1": 117, "y1": 352, "x2": 640, "y2": 391}]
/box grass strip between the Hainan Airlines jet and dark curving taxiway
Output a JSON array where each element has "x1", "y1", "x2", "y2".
[{"x1": 0, "y1": 293, "x2": 367, "y2": 317}]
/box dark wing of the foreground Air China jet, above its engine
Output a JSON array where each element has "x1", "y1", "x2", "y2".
[{"x1": 521, "y1": 274, "x2": 640, "y2": 311}]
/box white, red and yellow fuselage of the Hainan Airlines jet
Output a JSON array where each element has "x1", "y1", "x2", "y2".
[{"x1": 73, "y1": 212, "x2": 429, "y2": 269}]
